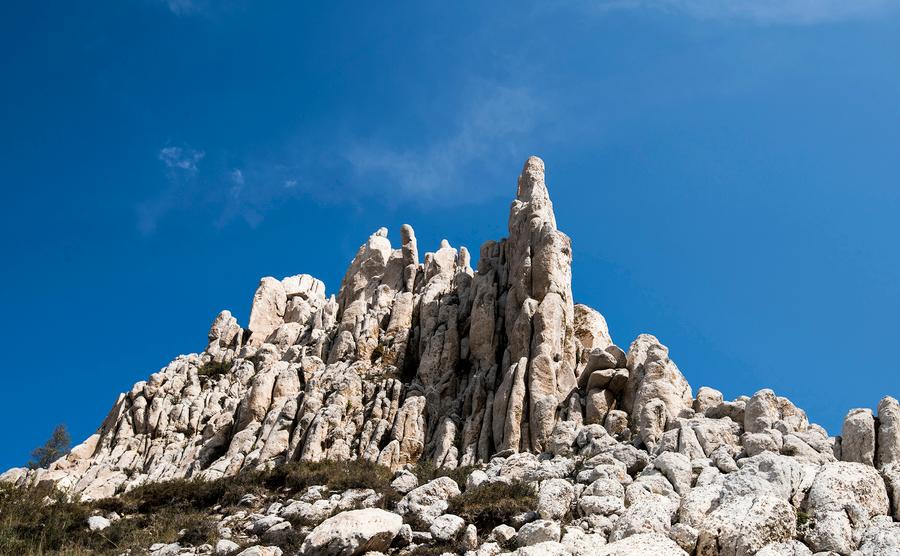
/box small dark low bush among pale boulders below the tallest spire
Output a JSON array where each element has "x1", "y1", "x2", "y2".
[{"x1": 447, "y1": 482, "x2": 537, "y2": 531}]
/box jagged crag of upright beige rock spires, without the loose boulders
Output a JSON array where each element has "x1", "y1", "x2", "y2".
[{"x1": 1, "y1": 157, "x2": 691, "y2": 498}]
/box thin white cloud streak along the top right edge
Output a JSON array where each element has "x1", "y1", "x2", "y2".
[{"x1": 577, "y1": 0, "x2": 897, "y2": 25}]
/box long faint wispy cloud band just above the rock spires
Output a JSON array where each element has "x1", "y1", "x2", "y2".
[{"x1": 138, "y1": 82, "x2": 547, "y2": 234}]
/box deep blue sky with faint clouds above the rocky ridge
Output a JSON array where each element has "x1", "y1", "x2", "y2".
[{"x1": 0, "y1": 0, "x2": 900, "y2": 468}]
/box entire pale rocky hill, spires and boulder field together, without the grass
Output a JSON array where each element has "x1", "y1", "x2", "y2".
[{"x1": 2, "y1": 157, "x2": 900, "y2": 556}]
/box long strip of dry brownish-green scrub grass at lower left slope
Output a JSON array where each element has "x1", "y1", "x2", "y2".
[{"x1": 0, "y1": 461, "x2": 397, "y2": 556}]
